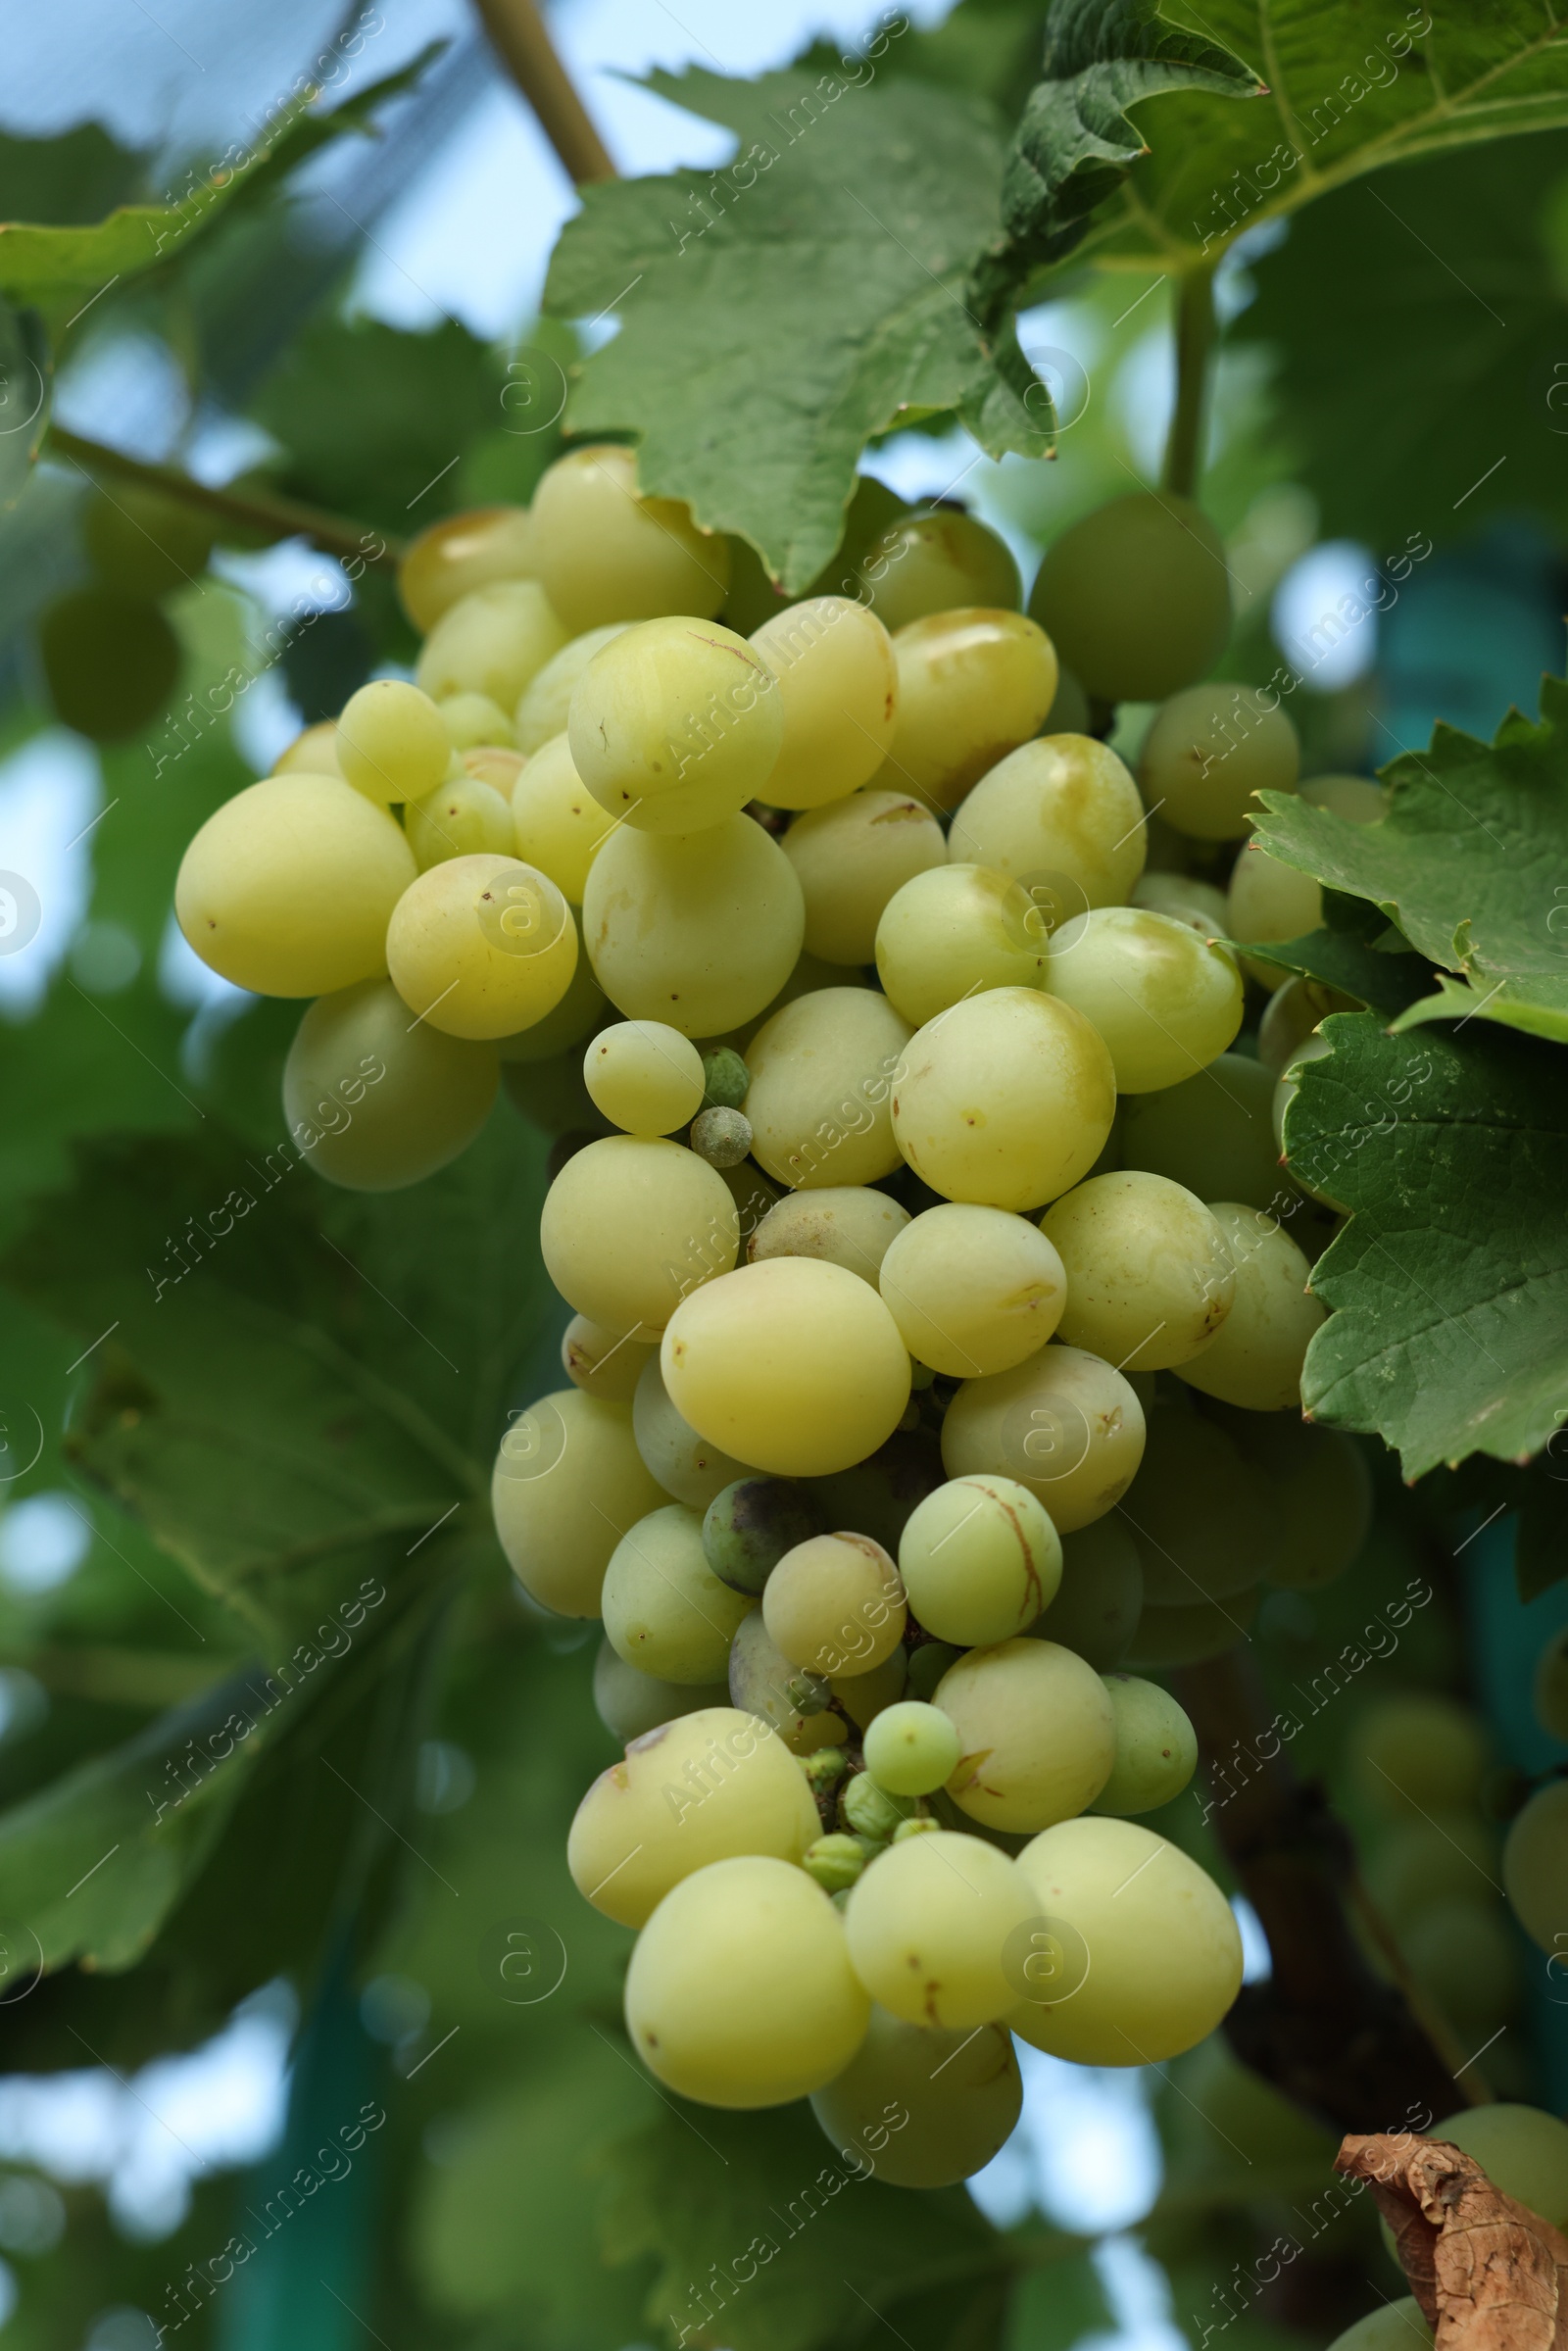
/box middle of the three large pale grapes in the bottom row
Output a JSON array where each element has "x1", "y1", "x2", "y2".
[{"x1": 844, "y1": 1829, "x2": 1034, "y2": 2032}]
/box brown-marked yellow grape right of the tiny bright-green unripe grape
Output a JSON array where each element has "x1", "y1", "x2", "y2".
[{"x1": 933, "y1": 1639, "x2": 1116, "y2": 1829}]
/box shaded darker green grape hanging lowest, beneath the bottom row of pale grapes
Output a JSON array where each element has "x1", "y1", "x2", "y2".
[{"x1": 811, "y1": 2005, "x2": 1022, "y2": 2188}]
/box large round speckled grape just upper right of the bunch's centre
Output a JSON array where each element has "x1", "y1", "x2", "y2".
[{"x1": 891, "y1": 988, "x2": 1116, "y2": 1208}]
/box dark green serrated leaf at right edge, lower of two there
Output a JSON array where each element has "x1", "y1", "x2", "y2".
[{"x1": 1286, "y1": 1013, "x2": 1568, "y2": 1479}]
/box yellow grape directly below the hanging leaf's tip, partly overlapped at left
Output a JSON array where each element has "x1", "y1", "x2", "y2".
[{"x1": 750, "y1": 595, "x2": 898, "y2": 808}]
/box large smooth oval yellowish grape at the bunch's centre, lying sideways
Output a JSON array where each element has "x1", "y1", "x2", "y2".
[{"x1": 658, "y1": 1259, "x2": 909, "y2": 1477}]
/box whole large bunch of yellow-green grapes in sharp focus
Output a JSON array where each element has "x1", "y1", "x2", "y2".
[{"x1": 166, "y1": 463, "x2": 1368, "y2": 2184}]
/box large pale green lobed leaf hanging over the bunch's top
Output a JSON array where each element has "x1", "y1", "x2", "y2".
[{"x1": 546, "y1": 69, "x2": 1051, "y2": 588}]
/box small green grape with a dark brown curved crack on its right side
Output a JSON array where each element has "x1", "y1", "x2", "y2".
[{"x1": 898, "y1": 1477, "x2": 1062, "y2": 1648}]
